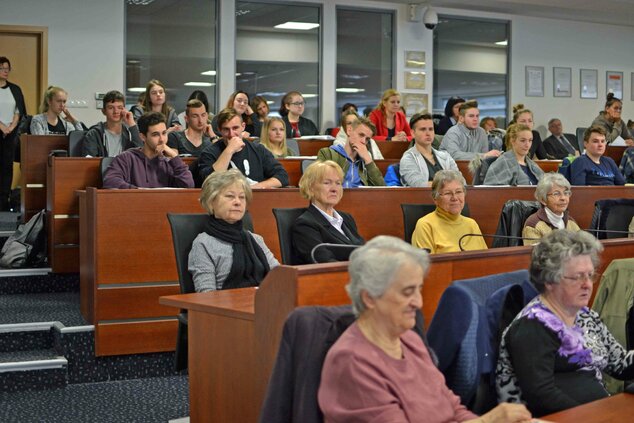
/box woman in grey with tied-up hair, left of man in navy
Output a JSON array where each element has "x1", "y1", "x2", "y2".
[{"x1": 484, "y1": 124, "x2": 544, "y2": 185}]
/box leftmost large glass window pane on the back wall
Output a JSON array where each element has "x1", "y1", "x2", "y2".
[{"x1": 126, "y1": 0, "x2": 216, "y2": 112}]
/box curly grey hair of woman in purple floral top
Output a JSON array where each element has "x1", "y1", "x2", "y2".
[{"x1": 529, "y1": 229, "x2": 603, "y2": 292}]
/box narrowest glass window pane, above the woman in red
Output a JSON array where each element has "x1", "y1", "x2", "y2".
[{"x1": 335, "y1": 8, "x2": 393, "y2": 122}]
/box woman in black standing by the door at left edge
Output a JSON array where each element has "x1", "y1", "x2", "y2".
[{"x1": 0, "y1": 56, "x2": 26, "y2": 211}]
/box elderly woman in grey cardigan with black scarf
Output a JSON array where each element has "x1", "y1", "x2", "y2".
[{"x1": 189, "y1": 169, "x2": 279, "y2": 292}]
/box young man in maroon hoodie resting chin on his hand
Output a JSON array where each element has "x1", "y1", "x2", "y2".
[{"x1": 103, "y1": 112, "x2": 194, "y2": 189}]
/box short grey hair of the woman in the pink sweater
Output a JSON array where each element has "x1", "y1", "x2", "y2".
[{"x1": 346, "y1": 235, "x2": 429, "y2": 317}]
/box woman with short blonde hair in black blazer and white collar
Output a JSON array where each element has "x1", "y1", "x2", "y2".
[{"x1": 291, "y1": 160, "x2": 364, "y2": 264}]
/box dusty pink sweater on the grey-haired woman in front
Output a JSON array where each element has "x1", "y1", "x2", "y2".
[{"x1": 318, "y1": 323, "x2": 477, "y2": 423}]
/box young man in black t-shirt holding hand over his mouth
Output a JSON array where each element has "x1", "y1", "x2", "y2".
[{"x1": 198, "y1": 108, "x2": 288, "y2": 188}]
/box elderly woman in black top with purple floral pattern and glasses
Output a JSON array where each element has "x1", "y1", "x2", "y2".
[{"x1": 496, "y1": 230, "x2": 634, "y2": 416}]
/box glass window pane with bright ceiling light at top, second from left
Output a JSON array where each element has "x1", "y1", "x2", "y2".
[{"x1": 235, "y1": 1, "x2": 320, "y2": 128}]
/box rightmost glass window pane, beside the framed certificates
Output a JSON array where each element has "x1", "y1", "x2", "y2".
[{"x1": 433, "y1": 16, "x2": 509, "y2": 126}]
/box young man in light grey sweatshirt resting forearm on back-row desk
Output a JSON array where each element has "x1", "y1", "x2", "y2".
[{"x1": 440, "y1": 100, "x2": 501, "y2": 160}]
